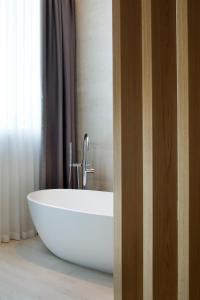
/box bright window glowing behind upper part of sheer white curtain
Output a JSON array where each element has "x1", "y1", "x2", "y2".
[{"x1": 0, "y1": 0, "x2": 41, "y2": 132}]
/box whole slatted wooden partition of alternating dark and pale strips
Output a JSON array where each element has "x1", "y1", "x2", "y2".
[{"x1": 113, "y1": 0, "x2": 195, "y2": 300}]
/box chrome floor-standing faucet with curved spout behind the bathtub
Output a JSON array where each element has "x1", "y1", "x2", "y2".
[{"x1": 82, "y1": 133, "x2": 95, "y2": 190}]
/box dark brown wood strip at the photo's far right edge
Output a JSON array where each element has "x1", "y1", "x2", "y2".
[{"x1": 188, "y1": 0, "x2": 200, "y2": 300}]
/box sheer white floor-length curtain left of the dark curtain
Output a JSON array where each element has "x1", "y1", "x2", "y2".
[{"x1": 0, "y1": 0, "x2": 41, "y2": 242}]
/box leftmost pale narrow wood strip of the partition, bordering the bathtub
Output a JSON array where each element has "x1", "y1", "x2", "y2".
[{"x1": 113, "y1": 0, "x2": 122, "y2": 300}]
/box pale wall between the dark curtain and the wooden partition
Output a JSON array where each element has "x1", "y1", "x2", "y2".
[{"x1": 76, "y1": 0, "x2": 113, "y2": 191}]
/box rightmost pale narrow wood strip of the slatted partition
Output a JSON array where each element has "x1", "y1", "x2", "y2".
[{"x1": 177, "y1": 0, "x2": 189, "y2": 300}]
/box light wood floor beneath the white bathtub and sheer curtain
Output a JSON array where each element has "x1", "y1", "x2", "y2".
[{"x1": 0, "y1": 238, "x2": 113, "y2": 300}]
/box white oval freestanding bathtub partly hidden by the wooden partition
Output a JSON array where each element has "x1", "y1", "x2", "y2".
[{"x1": 27, "y1": 189, "x2": 113, "y2": 273}]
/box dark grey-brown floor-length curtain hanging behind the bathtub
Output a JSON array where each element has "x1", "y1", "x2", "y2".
[{"x1": 40, "y1": 0, "x2": 76, "y2": 188}]
